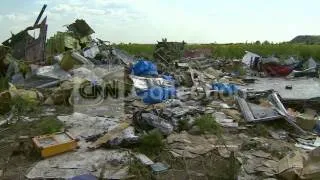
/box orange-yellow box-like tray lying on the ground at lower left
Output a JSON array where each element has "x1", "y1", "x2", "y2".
[{"x1": 32, "y1": 132, "x2": 78, "y2": 158}]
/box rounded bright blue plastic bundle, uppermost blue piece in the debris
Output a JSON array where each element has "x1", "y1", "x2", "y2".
[{"x1": 132, "y1": 60, "x2": 158, "y2": 76}]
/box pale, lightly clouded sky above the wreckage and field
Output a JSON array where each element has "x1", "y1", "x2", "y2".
[{"x1": 0, "y1": 0, "x2": 320, "y2": 43}]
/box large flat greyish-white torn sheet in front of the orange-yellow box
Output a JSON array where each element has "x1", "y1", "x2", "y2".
[{"x1": 26, "y1": 150, "x2": 130, "y2": 179}]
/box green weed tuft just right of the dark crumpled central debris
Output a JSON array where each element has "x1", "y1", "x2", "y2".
[{"x1": 195, "y1": 114, "x2": 222, "y2": 135}]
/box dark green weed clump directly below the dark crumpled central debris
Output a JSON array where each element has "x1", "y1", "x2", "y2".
[{"x1": 138, "y1": 130, "x2": 164, "y2": 156}]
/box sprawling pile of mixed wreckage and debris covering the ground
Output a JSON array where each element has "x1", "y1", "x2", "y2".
[{"x1": 0, "y1": 4, "x2": 320, "y2": 179}]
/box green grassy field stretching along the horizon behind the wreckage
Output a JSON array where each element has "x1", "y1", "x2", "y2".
[{"x1": 117, "y1": 43, "x2": 320, "y2": 60}]
